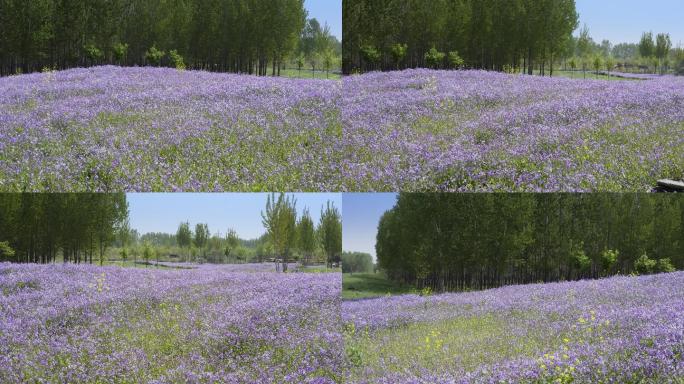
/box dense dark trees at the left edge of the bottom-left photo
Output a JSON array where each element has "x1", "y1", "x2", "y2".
[{"x1": 0, "y1": 193, "x2": 128, "y2": 264}]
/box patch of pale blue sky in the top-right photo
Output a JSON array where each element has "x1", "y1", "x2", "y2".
[{"x1": 575, "y1": 0, "x2": 684, "y2": 47}]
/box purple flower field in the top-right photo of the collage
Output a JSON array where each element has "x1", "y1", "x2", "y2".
[{"x1": 342, "y1": 70, "x2": 684, "y2": 191}]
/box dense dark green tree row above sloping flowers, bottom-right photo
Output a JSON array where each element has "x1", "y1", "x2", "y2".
[{"x1": 376, "y1": 194, "x2": 684, "y2": 291}]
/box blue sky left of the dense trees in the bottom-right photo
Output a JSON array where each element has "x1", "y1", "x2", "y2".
[{"x1": 342, "y1": 193, "x2": 397, "y2": 257}]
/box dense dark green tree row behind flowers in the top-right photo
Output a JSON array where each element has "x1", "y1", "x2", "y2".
[{"x1": 343, "y1": 0, "x2": 578, "y2": 74}]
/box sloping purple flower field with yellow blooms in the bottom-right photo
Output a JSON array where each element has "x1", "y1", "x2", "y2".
[{"x1": 342, "y1": 272, "x2": 684, "y2": 384}]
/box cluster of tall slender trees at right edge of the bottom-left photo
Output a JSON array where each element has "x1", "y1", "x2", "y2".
[{"x1": 261, "y1": 193, "x2": 342, "y2": 272}]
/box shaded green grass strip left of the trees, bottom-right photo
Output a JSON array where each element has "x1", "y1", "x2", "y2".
[{"x1": 342, "y1": 273, "x2": 415, "y2": 300}]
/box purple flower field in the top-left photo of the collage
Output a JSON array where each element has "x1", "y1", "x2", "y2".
[{"x1": 0, "y1": 66, "x2": 342, "y2": 192}]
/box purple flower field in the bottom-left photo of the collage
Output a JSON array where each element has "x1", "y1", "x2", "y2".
[{"x1": 0, "y1": 263, "x2": 344, "y2": 383}]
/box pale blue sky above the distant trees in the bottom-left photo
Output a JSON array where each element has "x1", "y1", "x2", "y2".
[{"x1": 126, "y1": 193, "x2": 342, "y2": 239}]
